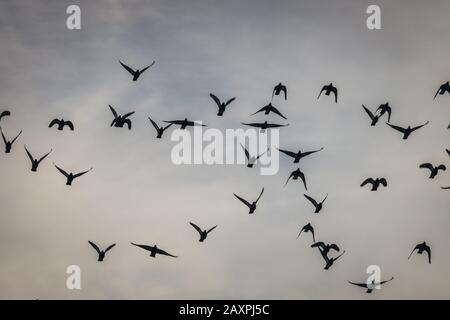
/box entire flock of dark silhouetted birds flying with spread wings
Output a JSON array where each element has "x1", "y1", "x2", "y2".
[{"x1": 0, "y1": 60, "x2": 450, "y2": 293}]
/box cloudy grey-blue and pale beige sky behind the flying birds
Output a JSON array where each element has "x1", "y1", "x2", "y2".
[{"x1": 0, "y1": 0, "x2": 450, "y2": 299}]
